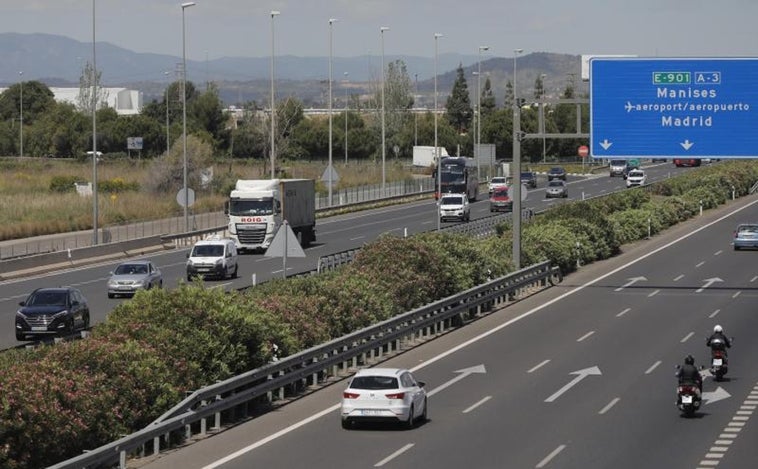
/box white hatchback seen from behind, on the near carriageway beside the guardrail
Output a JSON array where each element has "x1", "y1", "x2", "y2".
[{"x1": 340, "y1": 368, "x2": 427, "y2": 429}]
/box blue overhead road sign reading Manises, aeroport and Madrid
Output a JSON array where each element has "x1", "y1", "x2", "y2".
[{"x1": 590, "y1": 57, "x2": 758, "y2": 158}]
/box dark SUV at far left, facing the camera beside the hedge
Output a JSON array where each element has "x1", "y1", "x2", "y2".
[{"x1": 16, "y1": 287, "x2": 89, "y2": 340}]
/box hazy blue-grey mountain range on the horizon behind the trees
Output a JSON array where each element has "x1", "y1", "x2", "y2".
[{"x1": 0, "y1": 33, "x2": 584, "y2": 107}]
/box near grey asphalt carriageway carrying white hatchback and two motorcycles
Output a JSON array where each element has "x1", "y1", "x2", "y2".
[{"x1": 137, "y1": 190, "x2": 758, "y2": 469}]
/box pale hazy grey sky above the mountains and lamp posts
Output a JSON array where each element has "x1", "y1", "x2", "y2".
[{"x1": 0, "y1": 0, "x2": 758, "y2": 60}]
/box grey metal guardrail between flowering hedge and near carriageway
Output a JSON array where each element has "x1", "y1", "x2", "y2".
[{"x1": 49, "y1": 261, "x2": 560, "y2": 469}]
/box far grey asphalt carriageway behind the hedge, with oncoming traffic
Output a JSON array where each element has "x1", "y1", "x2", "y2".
[{"x1": 0, "y1": 163, "x2": 692, "y2": 350}]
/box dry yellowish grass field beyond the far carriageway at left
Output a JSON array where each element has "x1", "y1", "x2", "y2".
[{"x1": 0, "y1": 158, "x2": 411, "y2": 240}]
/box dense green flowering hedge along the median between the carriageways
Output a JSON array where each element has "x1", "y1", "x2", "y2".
[{"x1": 0, "y1": 161, "x2": 758, "y2": 469}]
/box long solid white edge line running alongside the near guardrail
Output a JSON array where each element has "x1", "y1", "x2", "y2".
[{"x1": 203, "y1": 200, "x2": 758, "y2": 469}]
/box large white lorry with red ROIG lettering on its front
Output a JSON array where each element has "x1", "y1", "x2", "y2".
[{"x1": 226, "y1": 179, "x2": 316, "y2": 251}]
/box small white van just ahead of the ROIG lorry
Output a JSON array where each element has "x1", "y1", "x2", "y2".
[{"x1": 187, "y1": 236, "x2": 239, "y2": 282}]
